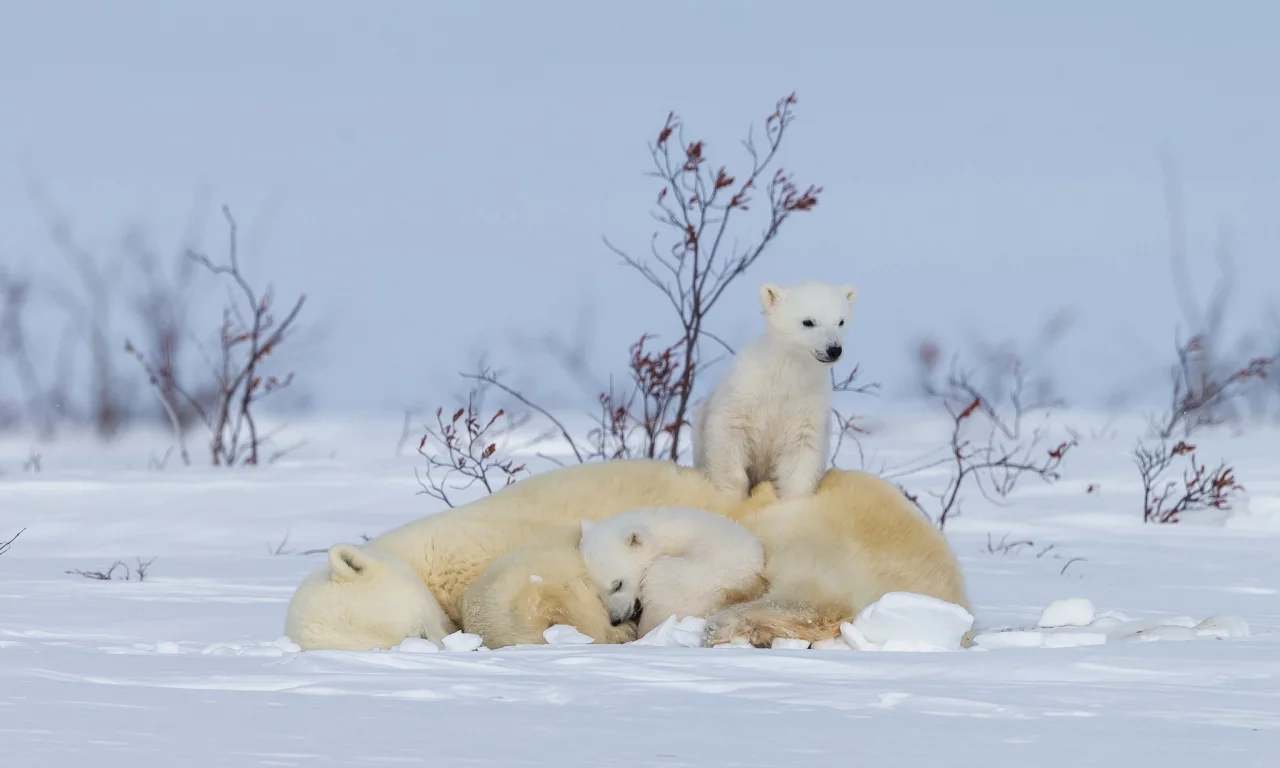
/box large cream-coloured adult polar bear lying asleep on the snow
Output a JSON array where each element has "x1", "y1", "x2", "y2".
[{"x1": 284, "y1": 460, "x2": 969, "y2": 650}]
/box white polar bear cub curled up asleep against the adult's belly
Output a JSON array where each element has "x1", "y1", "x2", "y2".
[{"x1": 579, "y1": 507, "x2": 768, "y2": 636}]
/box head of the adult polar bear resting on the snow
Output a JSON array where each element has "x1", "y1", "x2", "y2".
[{"x1": 284, "y1": 544, "x2": 457, "y2": 650}]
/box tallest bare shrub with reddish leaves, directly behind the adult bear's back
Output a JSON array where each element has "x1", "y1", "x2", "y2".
[{"x1": 453, "y1": 93, "x2": 839, "y2": 462}]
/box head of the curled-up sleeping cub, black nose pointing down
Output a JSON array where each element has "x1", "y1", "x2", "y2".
[{"x1": 579, "y1": 520, "x2": 657, "y2": 626}]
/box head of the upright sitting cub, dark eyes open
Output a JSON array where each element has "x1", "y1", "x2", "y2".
[{"x1": 760, "y1": 282, "x2": 858, "y2": 365}]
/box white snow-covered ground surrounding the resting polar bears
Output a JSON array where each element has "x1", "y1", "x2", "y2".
[{"x1": 0, "y1": 412, "x2": 1280, "y2": 768}]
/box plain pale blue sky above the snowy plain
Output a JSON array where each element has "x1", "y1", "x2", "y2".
[{"x1": 0, "y1": 0, "x2": 1280, "y2": 410}]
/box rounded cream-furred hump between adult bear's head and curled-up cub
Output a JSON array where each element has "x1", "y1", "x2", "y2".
[{"x1": 461, "y1": 540, "x2": 640, "y2": 649}]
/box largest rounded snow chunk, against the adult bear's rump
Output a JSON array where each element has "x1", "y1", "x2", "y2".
[{"x1": 841, "y1": 593, "x2": 973, "y2": 649}]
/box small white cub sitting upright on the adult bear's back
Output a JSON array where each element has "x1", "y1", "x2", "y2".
[{"x1": 694, "y1": 282, "x2": 858, "y2": 499}]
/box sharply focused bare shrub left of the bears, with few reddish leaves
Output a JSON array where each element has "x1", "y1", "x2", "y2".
[{"x1": 124, "y1": 205, "x2": 306, "y2": 466}]
